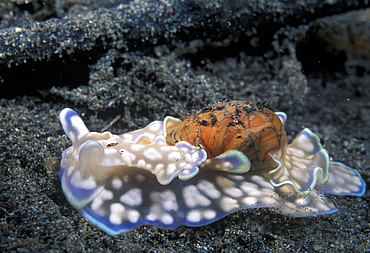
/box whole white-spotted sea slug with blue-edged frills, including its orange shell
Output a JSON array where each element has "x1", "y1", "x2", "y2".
[{"x1": 60, "y1": 101, "x2": 365, "y2": 235}]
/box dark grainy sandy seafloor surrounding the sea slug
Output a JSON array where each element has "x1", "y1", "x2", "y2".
[{"x1": 0, "y1": 0, "x2": 370, "y2": 252}]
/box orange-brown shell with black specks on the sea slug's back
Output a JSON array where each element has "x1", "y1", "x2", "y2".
[{"x1": 166, "y1": 101, "x2": 287, "y2": 170}]
